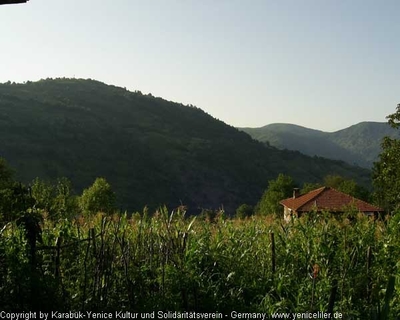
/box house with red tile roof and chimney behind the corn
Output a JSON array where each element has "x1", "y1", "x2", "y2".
[{"x1": 280, "y1": 187, "x2": 384, "y2": 221}]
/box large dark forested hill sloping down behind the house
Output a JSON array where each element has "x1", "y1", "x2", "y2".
[{"x1": 0, "y1": 79, "x2": 370, "y2": 212}]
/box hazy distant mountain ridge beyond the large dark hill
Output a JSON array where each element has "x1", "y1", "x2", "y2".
[{"x1": 239, "y1": 121, "x2": 400, "y2": 168}]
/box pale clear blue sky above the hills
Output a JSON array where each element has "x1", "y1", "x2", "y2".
[{"x1": 0, "y1": 0, "x2": 400, "y2": 131}]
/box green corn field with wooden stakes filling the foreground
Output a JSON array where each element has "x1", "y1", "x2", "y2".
[{"x1": 0, "y1": 208, "x2": 400, "y2": 319}]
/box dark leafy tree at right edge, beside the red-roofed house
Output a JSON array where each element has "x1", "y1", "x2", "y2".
[{"x1": 373, "y1": 104, "x2": 400, "y2": 212}]
